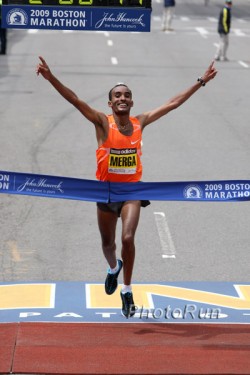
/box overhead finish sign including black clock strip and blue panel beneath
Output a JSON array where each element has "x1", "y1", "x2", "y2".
[{"x1": 2, "y1": 0, "x2": 151, "y2": 32}]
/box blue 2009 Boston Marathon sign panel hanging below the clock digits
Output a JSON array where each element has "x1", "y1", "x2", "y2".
[{"x1": 2, "y1": 5, "x2": 151, "y2": 32}]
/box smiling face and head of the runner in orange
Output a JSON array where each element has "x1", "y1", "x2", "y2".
[{"x1": 108, "y1": 86, "x2": 134, "y2": 114}]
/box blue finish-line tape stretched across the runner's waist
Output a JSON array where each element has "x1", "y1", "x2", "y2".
[{"x1": 0, "y1": 171, "x2": 250, "y2": 203}]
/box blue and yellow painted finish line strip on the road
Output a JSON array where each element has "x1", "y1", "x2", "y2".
[{"x1": 0, "y1": 282, "x2": 250, "y2": 324}]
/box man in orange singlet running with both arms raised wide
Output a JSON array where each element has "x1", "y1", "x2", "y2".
[{"x1": 36, "y1": 57, "x2": 217, "y2": 318}]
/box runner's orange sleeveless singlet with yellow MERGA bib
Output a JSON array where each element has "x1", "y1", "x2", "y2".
[{"x1": 96, "y1": 115, "x2": 142, "y2": 182}]
